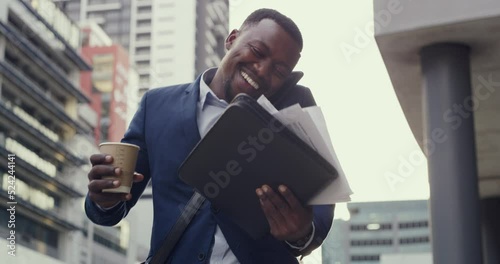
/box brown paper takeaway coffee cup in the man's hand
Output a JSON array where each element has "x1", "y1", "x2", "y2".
[{"x1": 99, "y1": 142, "x2": 140, "y2": 193}]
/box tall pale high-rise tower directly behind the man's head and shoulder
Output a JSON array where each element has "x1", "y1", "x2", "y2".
[{"x1": 56, "y1": 0, "x2": 229, "y2": 94}]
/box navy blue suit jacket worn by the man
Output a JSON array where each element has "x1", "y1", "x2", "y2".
[{"x1": 85, "y1": 73, "x2": 333, "y2": 263}]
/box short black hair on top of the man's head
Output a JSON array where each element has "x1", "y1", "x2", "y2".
[{"x1": 240, "y1": 8, "x2": 304, "y2": 50}]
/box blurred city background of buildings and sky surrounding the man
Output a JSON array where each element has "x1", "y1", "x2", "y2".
[{"x1": 0, "y1": 0, "x2": 500, "y2": 264}]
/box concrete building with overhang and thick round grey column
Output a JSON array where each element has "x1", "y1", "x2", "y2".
[{"x1": 373, "y1": 0, "x2": 500, "y2": 264}]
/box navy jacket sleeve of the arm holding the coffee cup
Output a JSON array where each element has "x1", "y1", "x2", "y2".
[{"x1": 85, "y1": 93, "x2": 151, "y2": 226}]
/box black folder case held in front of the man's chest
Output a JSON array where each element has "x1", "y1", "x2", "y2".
[{"x1": 179, "y1": 94, "x2": 338, "y2": 239}]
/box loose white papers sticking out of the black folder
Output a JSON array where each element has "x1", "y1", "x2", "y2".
[{"x1": 257, "y1": 95, "x2": 352, "y2": 204}]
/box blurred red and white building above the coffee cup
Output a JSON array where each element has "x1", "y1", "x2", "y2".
[{"x1": 81, "y1": 22, "x2": 139, "y2": 143}]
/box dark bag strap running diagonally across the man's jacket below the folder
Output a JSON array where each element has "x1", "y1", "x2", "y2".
[{"x1": 146, "y1": 192, "x2": 205, "y2": 264}]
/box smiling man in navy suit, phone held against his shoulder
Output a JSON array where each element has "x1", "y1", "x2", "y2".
[{"x1": 85, "y1": 9, "x2": 333, "y2": 263}]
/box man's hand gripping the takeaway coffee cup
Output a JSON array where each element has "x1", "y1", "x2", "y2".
[{"x1": 88, "y1": 154, "x2": 144, "y2": 208}]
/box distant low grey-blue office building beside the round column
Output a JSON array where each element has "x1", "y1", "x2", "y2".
[{"x1": 322, "y1": 200, "x2": 431, "y2": 264}]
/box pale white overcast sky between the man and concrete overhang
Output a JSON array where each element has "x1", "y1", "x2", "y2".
[{"x1": 230, "y1": 0, "x2": 429, "y2": 218}]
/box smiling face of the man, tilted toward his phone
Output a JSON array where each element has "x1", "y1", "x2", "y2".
[{"x1": 218, "y1": 19, "x2": 300, "y2": 102}]
